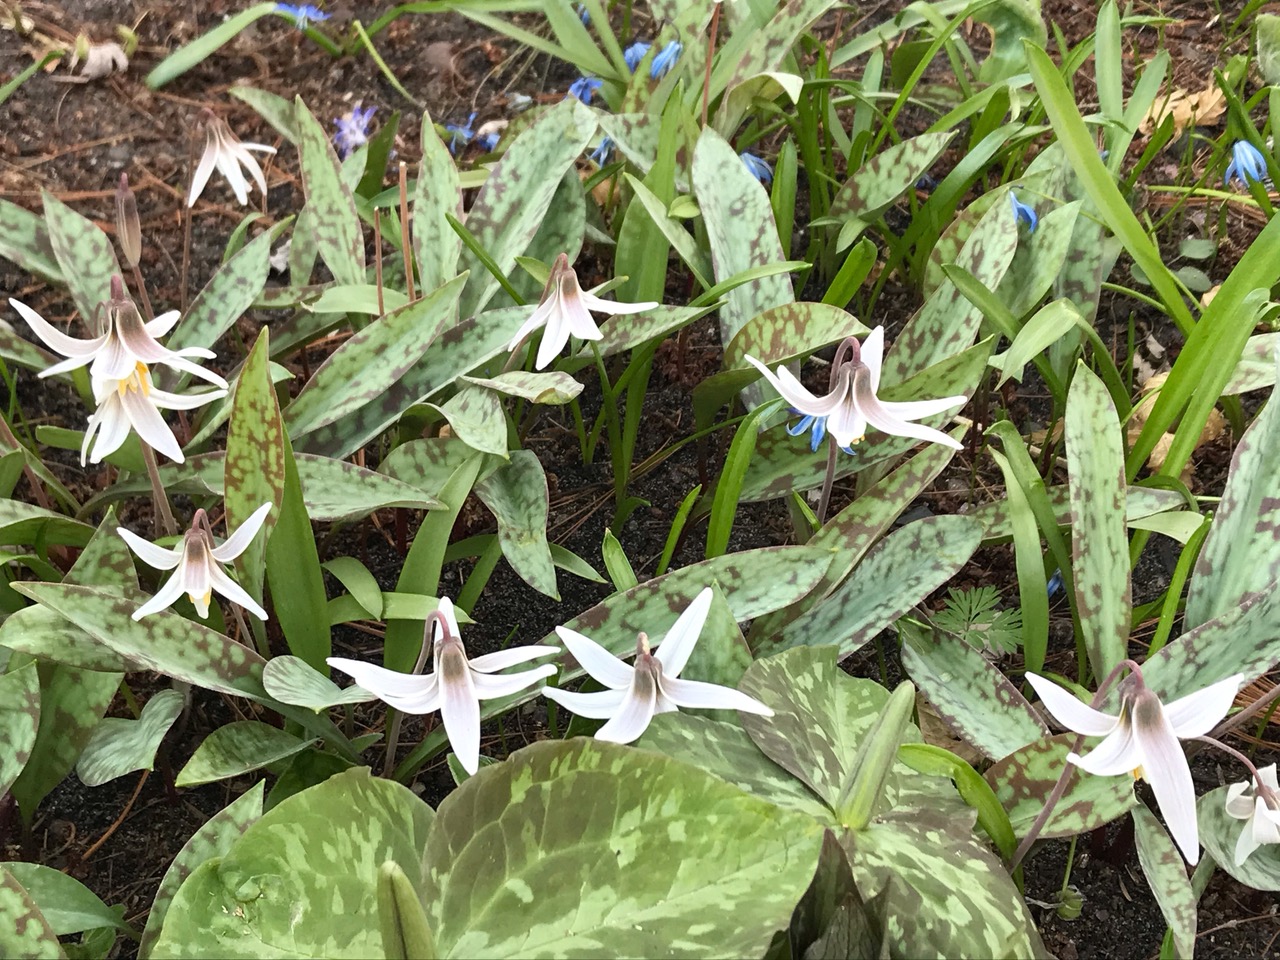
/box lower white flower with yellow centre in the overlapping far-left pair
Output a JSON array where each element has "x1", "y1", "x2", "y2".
[{"x1": 81, "y1": 362, "x2": 227, "y2": 466}]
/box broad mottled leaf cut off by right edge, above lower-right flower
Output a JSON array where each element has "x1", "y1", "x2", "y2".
[{"x1": 1183, "y1": 350, "x2": 1280, "y2": 630}]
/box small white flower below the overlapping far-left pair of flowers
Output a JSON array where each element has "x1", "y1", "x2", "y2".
[{"x1": 115, "y1": 503, "x2": 271, "y2": 620}]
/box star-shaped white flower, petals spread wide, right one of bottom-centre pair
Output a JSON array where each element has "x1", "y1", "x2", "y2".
[{"x1": 543, "y1": 588, "x2": 773, "y2": 744}]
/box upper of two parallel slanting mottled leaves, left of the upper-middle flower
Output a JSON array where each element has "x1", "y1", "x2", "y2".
[{"x1": 284, "y1": 275, "x2": 466, "y2": 442}]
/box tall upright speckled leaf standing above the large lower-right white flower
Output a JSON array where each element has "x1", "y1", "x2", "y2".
[{"x1": 1064, "y1": 364, "x2": 1133, "y2": 678}]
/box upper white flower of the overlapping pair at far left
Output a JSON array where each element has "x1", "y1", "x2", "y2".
[{"x1": 9, "y1": 274, "x2": 227, "y2": 390}]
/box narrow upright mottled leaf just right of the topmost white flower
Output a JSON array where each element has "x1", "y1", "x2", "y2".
[{"x1": 293, "y1": 96, "x2": 365, "y2": 284}]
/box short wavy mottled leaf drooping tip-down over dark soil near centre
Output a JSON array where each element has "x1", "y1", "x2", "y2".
[{"x1": 475, "y1": 453, "x2": 559, "y2": 600}]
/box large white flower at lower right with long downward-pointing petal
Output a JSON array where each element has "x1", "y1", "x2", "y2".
[{"x1": 1027, "y1": 673, "x2": 1244, "y2": 864}]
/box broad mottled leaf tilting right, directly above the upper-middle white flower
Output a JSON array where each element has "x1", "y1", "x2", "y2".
[{"x1": 460, "y1": 97, "x2": 595, "y2": 317}]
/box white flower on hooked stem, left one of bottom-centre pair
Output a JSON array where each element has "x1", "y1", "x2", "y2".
[{"x1": 325, "y1": 596, "x2": 559, "y2": 773}]
